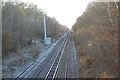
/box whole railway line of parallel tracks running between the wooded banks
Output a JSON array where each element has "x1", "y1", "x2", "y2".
[{"x1": 15, "y1": 34, "x2": 78, "y2": 80}]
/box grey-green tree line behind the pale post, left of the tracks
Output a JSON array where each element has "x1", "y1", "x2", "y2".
[{"x1": 2, "y1": 2, "x2": 67, "y2": 56}]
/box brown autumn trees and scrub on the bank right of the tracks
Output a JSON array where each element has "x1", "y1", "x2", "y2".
[{"x1": 72, "y1": 2, "x2": 120, "y2": 78}]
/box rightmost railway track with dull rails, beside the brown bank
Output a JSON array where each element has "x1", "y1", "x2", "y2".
[{"x1": 55, "y1": 34, "x2": 79, "y2": 79}]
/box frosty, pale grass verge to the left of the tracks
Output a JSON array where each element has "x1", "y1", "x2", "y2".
[{"x1": 2, "y1": 38, "x2": 49, "y2": 78}]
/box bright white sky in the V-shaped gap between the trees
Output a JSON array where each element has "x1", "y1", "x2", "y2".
[{"x1": 21, "y1": 0, "x2": 92, "y2": 29}]
